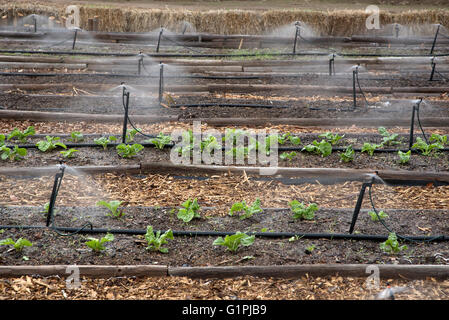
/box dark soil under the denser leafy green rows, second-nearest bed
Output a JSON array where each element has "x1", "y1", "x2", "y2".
[{"x1": 0, "y1": 131, "x2": 449, "y2": 171}]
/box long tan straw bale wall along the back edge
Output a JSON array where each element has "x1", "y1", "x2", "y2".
[{"x1": 0, "y1": 3, "x2": 449, "y2": 36}]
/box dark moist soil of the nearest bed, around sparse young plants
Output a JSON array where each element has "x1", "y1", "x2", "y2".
[{"x1": 0, "y1": 207, "x2": 449, "y2": 266}]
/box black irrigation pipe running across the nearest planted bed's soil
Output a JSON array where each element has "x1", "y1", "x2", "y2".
[{"x1": 0, "y1": 225, "x2": 449, "y2": 242}]
